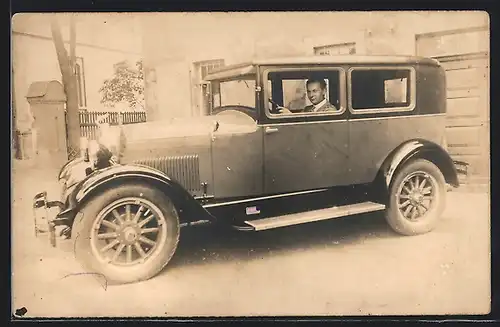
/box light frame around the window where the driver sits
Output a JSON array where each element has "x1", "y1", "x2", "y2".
[{"x1": 262, "y1": 65, "x2": 347, "y2": 121}]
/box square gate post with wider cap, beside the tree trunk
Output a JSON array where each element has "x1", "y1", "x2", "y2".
[{"x1": 26, "y1": 81, "x2": 67, "y2": 167}]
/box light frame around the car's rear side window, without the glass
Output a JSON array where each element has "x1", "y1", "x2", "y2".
[{"x1": 347, "y1": 65, "x2": 417, "y2": 115}]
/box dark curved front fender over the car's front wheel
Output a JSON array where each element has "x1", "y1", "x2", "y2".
[{"x1": 65, "y1": 164, "x2": 215, "y2": 223}]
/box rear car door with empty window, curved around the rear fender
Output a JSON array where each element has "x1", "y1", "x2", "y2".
[{"x1": 347, "y1": 65, "x2": 420, "y2": 184}]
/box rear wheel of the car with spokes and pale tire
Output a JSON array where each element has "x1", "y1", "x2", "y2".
[{"x1": 386, "y1": 159, "x2": 446, "y2": 236}]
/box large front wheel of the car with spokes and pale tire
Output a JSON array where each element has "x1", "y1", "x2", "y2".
[{"x1": 72, "y1": 183, "x2": 180, "y2": 284}]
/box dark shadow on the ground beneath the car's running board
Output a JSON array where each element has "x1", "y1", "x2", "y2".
[{"x1": 164, "y1": 213, "x2": 399, "y2": 270}]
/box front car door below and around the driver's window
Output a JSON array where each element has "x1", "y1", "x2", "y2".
[{"x1": 262, "y1": 67, "x2": 349, "y2": 194}]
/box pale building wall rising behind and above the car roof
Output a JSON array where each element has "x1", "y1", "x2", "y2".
[{"x1": 143, "y1": 12, "x2": 489, "y2": 118}]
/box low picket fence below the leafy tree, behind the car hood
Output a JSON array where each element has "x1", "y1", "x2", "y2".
[{"x1": 79, "y1": 111, "x2": 146, "y2": 140}]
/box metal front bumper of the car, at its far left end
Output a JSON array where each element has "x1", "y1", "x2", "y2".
[{"x1": 33, "y1": 191, "x2": 69, "y2": 247}]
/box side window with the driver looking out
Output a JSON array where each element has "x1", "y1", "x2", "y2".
[{"x1": 266, "y1": 69, "x2": 343, "y2": 118}]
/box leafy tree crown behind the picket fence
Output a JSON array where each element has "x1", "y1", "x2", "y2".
[{"x1": 99, "y1": 60, "x2": 144, "y2": 109}]
